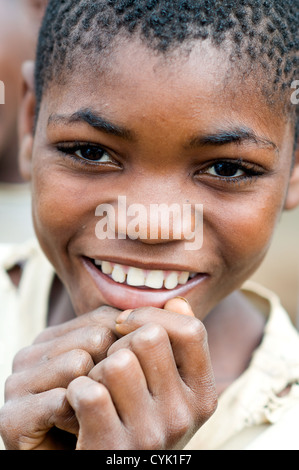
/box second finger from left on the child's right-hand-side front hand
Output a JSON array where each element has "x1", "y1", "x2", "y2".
[{"x1": 89, "y1": 349, "x2": 151, "y2": 426}]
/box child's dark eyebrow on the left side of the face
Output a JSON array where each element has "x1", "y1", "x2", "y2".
[{"x1": 48, "y1": 109, "x2": 134, "y2": 140}]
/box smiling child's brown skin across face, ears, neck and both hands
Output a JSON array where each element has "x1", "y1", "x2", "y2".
[{"x1": 0, "y1": 38, "x2": 299, "y2": 449}]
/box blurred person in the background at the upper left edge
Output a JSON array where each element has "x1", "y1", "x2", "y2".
[{"x1": 0, "y1": 0, "x2": 47, "y2": 243}]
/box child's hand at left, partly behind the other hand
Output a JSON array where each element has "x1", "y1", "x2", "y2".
[{"x1": 0, "y1": 307, "x2": 120, "y2": 450}]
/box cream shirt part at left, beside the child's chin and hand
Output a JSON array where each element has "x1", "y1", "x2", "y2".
[{"x1": 0, "y1": 240, "x2": 54, "y2": 406}]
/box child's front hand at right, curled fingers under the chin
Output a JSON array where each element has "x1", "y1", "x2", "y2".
[{"x1": 66, "y1": 299, "x2": 217, "y2": 450}]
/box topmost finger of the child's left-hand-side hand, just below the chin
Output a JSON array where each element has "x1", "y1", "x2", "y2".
[{"x1": 34, "y1": 306, "x2": 120, "y2": 344}]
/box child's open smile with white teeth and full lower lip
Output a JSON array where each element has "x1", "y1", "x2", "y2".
[{"x1": 82, "y1": 257, "x2": 208, "y2": 310}]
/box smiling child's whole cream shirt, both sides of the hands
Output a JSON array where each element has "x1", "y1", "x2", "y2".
[{"x1": 0, "y1": 241, "x2": 299, "y2": 450}]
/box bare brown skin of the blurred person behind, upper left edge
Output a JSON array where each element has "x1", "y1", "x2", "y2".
[{"x1": 0, "y1": 0, "x2": 47, "y2": 183}]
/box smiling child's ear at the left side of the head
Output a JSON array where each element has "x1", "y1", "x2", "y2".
[{"x1": 19, "y1": 61, "x2": 36, "y2": 181}]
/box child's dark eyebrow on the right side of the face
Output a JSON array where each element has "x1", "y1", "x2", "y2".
[{"x1": 189, "y1": 127, "x2": 278, "y2": 150}]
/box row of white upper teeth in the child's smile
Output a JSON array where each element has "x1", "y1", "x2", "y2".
[{"x1": 94, "y1": 260, "x2": 197, "y2": 290}]
